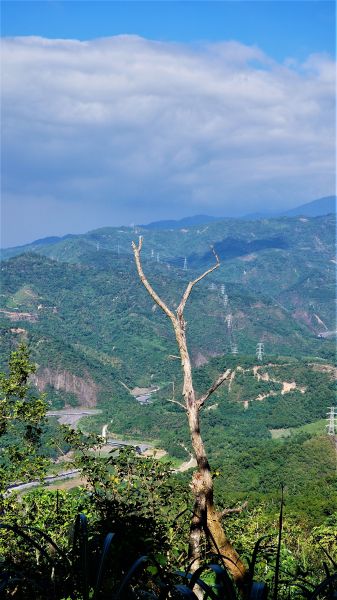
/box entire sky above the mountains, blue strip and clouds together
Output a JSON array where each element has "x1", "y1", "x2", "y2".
[{"x1": 1, "y1": 0, "x2": 335, "y2": 247}]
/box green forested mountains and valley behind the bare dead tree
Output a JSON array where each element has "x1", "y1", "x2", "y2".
[{"x1": 0, "y1": 215, "x2": 336, "y2": 522}]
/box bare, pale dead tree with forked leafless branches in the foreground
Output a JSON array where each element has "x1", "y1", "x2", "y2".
[{"x1": 132, "y1": 237, "x2": 247, "y2": 588}]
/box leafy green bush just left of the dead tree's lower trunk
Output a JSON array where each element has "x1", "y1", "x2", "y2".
[{"x1": 65, "y1": 433, "x2": 191, "y2": 564}]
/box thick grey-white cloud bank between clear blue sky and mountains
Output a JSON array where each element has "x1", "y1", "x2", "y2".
[{"x1": 2, "y1": 36, "x2": 335, "y2": 246}]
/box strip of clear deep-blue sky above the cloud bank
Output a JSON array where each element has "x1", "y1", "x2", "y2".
[{"x1": 2, "y1": 0, "x2": 335, "y2": 60}]
